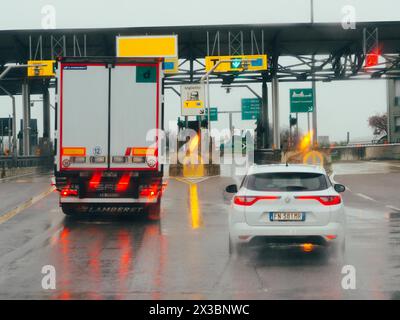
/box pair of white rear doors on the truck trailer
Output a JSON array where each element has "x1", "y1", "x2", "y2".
[{"x1": 58, "y1": 63, "x2": 161, "y2": 171}]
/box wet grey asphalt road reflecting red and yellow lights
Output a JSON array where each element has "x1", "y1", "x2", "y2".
[{"x1": 0, "y1": 162, "x2": 400, "y2": 299}]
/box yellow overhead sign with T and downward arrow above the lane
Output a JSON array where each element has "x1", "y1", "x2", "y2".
[{"x1": 205, "y1": 54, "x2": 268, "y2": 72}]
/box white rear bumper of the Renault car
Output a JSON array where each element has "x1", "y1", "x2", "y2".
[{"x1": 230, "y1": 222, "x2": 344, "y2": 244}]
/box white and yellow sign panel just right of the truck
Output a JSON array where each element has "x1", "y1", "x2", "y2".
[{"x1": 181, "y1": 84, "x2": 205, "y2": 116}]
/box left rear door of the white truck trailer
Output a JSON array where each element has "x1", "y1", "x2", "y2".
[{"x1": 58, "y1": 63, "x2": 110, "y2": 171}]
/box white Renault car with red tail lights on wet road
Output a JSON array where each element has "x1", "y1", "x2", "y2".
[{"x1": 226, "y1": 164, "x2": 346, "y2": 254}]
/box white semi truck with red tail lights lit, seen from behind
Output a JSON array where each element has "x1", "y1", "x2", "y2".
[{"x1": 54, "y1": 58, "x2": 164, "y2": 219}]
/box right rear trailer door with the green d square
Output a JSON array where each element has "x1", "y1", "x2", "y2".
[{"x1": 110, "y1": 63, "x2": 161, "y2": 171}]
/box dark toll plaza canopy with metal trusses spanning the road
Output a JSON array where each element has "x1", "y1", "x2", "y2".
[{"x1": 0, "y1": 21, "x2": 400, "y2": 94}]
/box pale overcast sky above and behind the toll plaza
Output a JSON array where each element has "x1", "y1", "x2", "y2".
[{"x1": 0, "y1": 0, "x2": 400, "y2": 145}]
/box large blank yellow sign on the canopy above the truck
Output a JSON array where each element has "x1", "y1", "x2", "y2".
[{"x1": 116, "y1": 35, "x2": 178, "y2": 58}]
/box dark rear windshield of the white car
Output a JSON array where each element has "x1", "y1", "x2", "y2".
[{"x1": 244, "y1": 172, "x2": 328, "y2": 191}]
